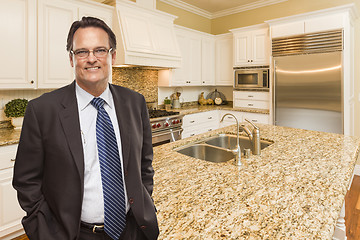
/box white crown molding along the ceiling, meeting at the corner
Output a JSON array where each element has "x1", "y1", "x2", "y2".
[{"x1": 160, "y1": 0, "x2": 288, "y2": 19}]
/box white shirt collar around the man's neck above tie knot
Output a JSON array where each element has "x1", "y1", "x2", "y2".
[{"x1": 75, "y1": 82, "x2": 113, "y2": 111}]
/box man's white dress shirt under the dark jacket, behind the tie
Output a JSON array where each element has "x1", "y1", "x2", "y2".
[{"x1": 76, "y1": 83, "x2": 129, "y2": 223}]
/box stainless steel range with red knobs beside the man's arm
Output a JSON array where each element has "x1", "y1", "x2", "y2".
[{"x1": 149, "y1": 109, "x2": 184, "y2": 146}]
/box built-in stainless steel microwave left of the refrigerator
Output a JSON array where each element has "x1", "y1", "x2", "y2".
[{"x1": 234, "y1": 67, "x2": 269, "y2": 89}]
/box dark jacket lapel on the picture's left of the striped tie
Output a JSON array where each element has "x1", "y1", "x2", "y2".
[{"x1": 59, "y1": 81, "x2": 84, "y2": 186}]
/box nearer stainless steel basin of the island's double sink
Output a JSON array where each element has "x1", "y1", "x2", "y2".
[{"x1": 177, "y1": 143, "x2": 234, "y2": 163}]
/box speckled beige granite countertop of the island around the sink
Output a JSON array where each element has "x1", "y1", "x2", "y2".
[{"x1": 153, "y1": 124, "x2": 360, "y2": 239}]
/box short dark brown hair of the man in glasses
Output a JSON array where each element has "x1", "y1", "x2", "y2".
[{"x1": 66, "y1": 17, "x2": 116, "y2": 52}]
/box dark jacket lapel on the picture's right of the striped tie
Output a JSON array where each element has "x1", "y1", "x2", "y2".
[{"x1": 110, "y1": 84, "x2": 131, "y2": 172}]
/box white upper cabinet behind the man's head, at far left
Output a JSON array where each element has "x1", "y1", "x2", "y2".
[{"x1": 0, "y1": 0, "x2": 113, "y2": 89}]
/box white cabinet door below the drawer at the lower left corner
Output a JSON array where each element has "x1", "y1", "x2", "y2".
[{"x1": 0, "y1": 168, "x2": 25, "y2": 239}]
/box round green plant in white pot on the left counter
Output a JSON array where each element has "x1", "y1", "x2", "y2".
[{"x1": 4, "y1": 98, "x2": 29, "y2": 129}]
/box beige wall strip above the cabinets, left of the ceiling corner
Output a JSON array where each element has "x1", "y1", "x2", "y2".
[{"x1": 156, "y1": 0, "x2": 211, "y2": 33}]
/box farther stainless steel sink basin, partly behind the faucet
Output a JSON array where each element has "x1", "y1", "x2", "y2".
[{"x1": 205, "y1": 134, "x2": 272, "y2": 150}]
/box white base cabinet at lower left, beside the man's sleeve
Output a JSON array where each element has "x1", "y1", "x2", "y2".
[{"x1": 0, "y1": 144, "x2": 25, "y2": 239}]
